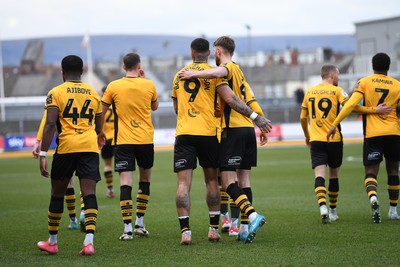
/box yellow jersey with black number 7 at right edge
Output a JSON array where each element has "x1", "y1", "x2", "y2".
[{"x1": 354, "y1": 74, "x2": 400, "y2": 138}]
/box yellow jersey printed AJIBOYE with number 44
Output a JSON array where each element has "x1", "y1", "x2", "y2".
[{"x1": 46, "y1": 81, "x2": 101, "y2": 154}]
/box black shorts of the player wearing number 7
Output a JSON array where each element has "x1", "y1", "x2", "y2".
[{"x1": 363, "y1": 135, "x2": 400, "y2": 166}]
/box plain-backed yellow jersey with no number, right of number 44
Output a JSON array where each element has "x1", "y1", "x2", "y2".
[{"x1": 101, "y1": 77, "x2": 157, "y2": 145}]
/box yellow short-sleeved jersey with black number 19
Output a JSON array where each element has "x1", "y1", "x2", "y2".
[{"x1": 301, "y1": 83, "x2": 349, "y2": 142}]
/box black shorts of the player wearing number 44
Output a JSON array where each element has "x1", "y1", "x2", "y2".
[{"x1": 50, "y1": 152, "x2": 101, "y2": 182}]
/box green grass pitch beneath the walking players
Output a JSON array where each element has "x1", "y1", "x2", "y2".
[{"x1": 0, "y1": 144, "x2": 400, "y2": 266}]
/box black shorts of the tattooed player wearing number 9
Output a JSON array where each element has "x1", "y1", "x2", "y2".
[{"x1": 174, "y1": 135, "x2": 218, "y2": 172}]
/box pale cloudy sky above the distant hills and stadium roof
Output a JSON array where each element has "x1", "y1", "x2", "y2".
[{"x1": 0, "y1": 0, "x2": 400, "y2": 40}]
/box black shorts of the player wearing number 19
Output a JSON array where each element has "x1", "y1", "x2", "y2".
[{"x1": 310, "y1": 141, "x2": 343, "y2": 169}]
